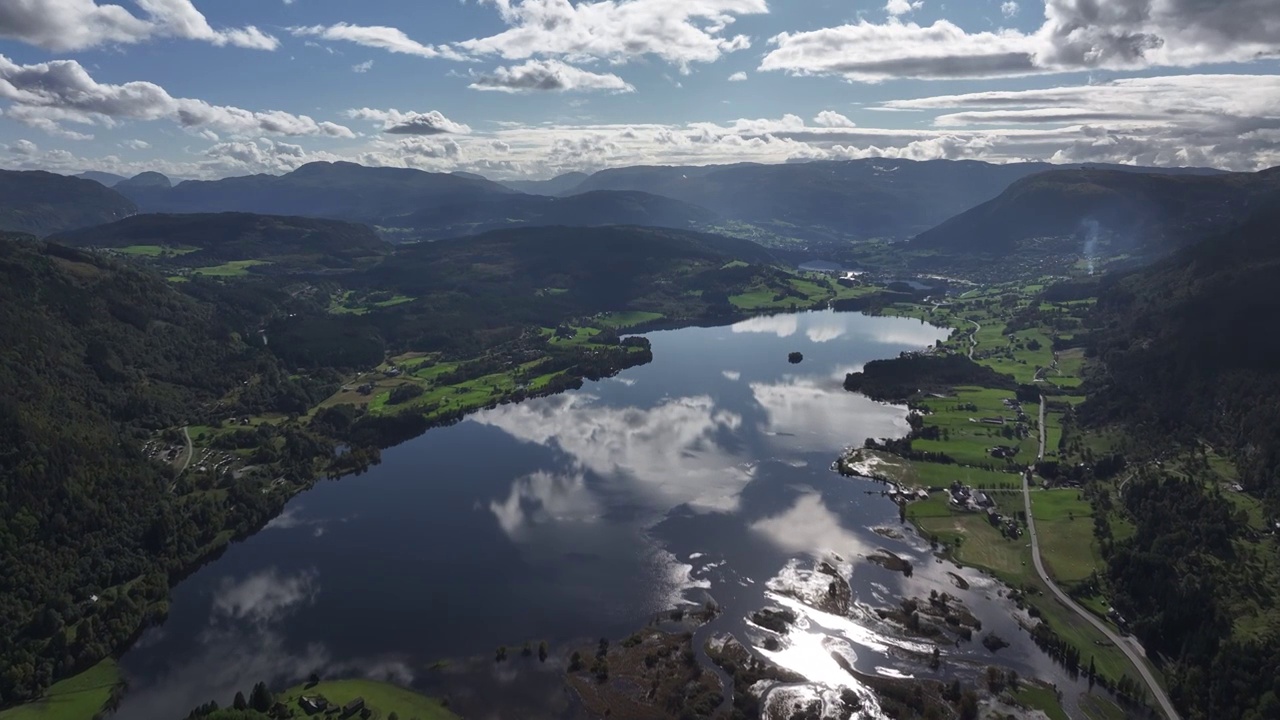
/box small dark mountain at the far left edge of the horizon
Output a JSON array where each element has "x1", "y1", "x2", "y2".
[{"x1": 0, "y1": 170, "x2": 138, "y2": 236}]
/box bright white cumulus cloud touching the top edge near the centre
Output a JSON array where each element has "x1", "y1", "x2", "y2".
[{"x1": 458, "y1": 0, "x2": 769, "y2": 68}]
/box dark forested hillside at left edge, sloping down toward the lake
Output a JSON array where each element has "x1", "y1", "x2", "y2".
[{"x1": 0, "y1": 234, "x2": 340, "y2": 703}]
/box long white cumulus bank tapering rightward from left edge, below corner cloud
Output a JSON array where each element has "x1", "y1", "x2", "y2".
[{"x1": 0, "y1": 55, "x2": 355, "y2": 138}]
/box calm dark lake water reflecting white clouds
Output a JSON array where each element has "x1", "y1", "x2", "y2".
[{"x1": 116, "y1": 311, "x2": 1080, "y2": 720}]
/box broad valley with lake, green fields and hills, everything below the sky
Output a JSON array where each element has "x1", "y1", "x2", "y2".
[{"x1": 0, "y1": 156, "x2": 1277, "y2": 720}]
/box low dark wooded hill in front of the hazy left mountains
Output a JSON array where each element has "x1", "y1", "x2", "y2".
[{"x1": 50, "y1": 213, "x2": 390, "y2": 269}]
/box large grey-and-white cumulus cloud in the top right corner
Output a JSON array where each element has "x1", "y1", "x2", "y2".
[{"x1": 760, "y1": 0, "x2": 1280, "y2": 82}]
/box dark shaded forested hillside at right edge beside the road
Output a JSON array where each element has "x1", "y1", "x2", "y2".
[{"x1": 1080, "y1": 197, "x2": 1280, "y2": 719}]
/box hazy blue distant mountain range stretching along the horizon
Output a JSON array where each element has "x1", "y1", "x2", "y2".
[{"x1": 64, "y1": 159, "x2": 1233, "y2": 245}]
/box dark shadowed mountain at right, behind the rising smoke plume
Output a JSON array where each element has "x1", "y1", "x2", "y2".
[{"x1": 911, "y1": 168, "x2": 1280, "y2": 255}]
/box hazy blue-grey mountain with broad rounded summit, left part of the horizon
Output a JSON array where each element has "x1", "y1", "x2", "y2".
[{"x1": 123, "y1": 163, "x2": 515, "y2": 225}]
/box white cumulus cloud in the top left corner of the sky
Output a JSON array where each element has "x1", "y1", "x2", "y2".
[{"x1": 0, "y1": 0, "x2": 280, "y2": 51}]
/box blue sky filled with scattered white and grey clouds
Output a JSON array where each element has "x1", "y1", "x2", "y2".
[{"x1": 0, "y1": 0, "x2": 1280, "y2": 179}]
